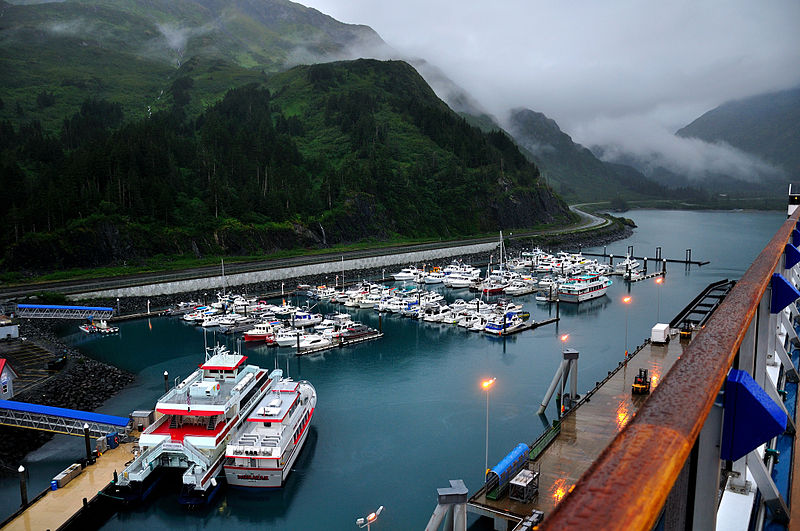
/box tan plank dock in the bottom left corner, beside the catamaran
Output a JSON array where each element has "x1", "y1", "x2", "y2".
[{"x1": 3, "y1": 443, "x2": 134, "y2": 531}]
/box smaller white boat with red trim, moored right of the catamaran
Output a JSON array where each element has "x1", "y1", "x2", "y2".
[{"x1": 224, "y1": 369, "x2": 317, "y2": 488}]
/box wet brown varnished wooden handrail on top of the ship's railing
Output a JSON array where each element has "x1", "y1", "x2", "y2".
[{"x1": 540, "y1": 211, "x2": 800, "y2": 531}]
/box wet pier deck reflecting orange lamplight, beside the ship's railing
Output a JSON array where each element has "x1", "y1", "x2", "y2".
[{"x1": 468, "y1": 336, "x2": 683, "y2": 529}]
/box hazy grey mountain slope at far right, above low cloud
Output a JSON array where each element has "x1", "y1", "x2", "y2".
[{"x1": 676, "y1": 88, "x2": 800, "y2": 176}]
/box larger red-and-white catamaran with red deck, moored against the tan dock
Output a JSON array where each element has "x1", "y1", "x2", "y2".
[{"x1": 109, "y1": 346, "x2": 271, "y2": 505}]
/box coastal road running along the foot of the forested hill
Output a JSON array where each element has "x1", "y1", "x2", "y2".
[{"x1": 0, "y1": 205, "x2": 611, "y2": 302}]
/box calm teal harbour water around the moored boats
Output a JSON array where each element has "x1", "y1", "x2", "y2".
[{"x1": 0, "y1": 210, "x2": 785, "y2": 530}]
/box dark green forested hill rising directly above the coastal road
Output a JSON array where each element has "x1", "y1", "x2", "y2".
[{"x1": 0, "y1": 59, "x2": 570, "y2": 269}]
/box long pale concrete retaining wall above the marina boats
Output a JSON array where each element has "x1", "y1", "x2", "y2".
[{"x1": 69, "y1": 243, "x2": 498, "y2": 300}]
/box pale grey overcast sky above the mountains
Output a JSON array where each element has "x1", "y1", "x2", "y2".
[{"x1": 301, "y1": 0, "x2": 800, "y2": 179}]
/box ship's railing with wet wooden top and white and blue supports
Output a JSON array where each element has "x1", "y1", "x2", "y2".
[{"x1": 540, "y1": 211, "x2": 800, "y2": 530}]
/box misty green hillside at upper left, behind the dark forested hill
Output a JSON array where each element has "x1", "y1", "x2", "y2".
[{"x1": 0, "y1": 0, "x2": 385, "y2": 131}]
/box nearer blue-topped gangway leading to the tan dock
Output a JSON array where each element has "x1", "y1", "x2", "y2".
[{"x1": 0, "y1": 400, "x2": 130, "y2": 437}]
